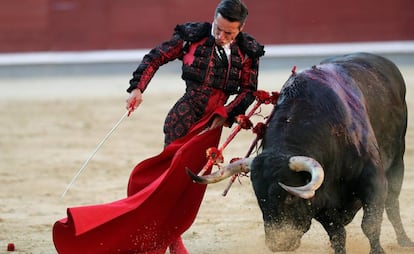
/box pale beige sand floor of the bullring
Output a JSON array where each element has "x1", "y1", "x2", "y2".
[{"x1": 0, "y1": 54, "x2": 414, "y2": 254}]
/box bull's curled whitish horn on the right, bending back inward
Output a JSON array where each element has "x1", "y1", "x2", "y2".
[{"x1": 279, "y1": 156, "x2": 325, "y2": 199}]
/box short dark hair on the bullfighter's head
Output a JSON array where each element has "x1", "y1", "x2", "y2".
[{"x1": 215, "y1": 0, "x2": 249, "y2": 25}]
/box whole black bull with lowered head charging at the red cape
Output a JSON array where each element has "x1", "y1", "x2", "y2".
[{"x1": 188, "y1": 53, "x2": 413, "y2": 253}]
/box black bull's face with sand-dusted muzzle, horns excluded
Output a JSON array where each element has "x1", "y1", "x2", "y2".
[{"x1": 251, "y1": 153, "x2": 312, "y2": 251}]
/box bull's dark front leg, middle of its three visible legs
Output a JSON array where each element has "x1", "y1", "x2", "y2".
[{"x1": 359, "y1": 165, "x2": 387, "y2": 254}]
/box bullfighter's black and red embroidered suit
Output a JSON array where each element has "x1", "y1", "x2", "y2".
[{"x1": 127, "y1": 23, "x2": 264, "y2": 144}]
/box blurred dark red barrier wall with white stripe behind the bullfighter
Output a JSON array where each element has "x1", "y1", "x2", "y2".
[{"x1": 0, "y1": 0, "x2": 414, "y2": 73}]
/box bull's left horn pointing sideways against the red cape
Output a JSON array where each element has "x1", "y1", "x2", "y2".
[{"x1": 186, "y1": 158, "x2": 253, "y2": 184}]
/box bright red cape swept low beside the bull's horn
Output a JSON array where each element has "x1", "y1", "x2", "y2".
[{"x1": 53, "y1": 107, "x2": 226, "y2": 254}]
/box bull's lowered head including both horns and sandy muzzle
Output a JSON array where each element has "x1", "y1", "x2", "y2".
[{"x1": 188, "y1": 153, "x2": 324, "y2": 251}]
